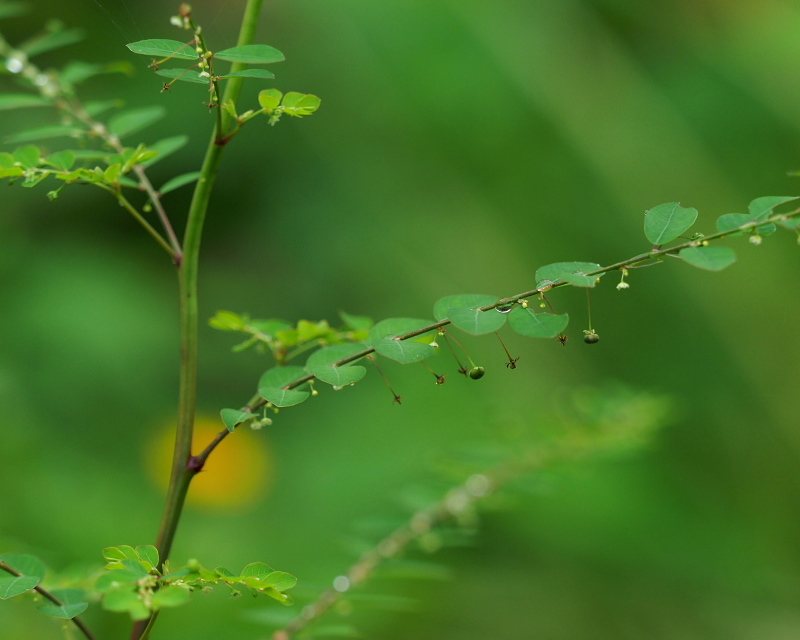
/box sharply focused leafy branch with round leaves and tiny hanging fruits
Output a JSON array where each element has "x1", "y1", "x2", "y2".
[{"x1": 202, "y1": 196, "x2": 800, "y2": 460}]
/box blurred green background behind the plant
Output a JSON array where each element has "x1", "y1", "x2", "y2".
[{"x1": 0, "y1": 0, "x2": 800, "y2": 640}]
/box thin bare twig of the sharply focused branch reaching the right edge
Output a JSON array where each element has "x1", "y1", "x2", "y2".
[{"x1": 192, "y1": 209, "x2": 800, "y2": 462}]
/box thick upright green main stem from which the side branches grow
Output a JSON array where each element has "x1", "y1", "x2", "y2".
[{"x1": 131, "y1": 0, "x2": 263, "y2": 639}]
